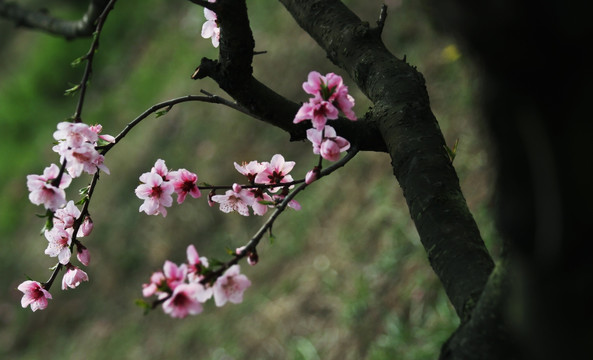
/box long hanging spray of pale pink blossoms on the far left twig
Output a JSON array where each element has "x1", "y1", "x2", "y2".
[{"x1": 18, "y1": 122, "x2": 115, "y2": 311}]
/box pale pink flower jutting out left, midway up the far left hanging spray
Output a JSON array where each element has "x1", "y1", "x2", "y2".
[{"x1": 27, "y1": 164, "x2": 72, "y2": 211}]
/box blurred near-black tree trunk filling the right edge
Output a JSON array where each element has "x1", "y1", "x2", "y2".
[{"x1": 430, "y1": 0, "x2": 593, "y2": 359}]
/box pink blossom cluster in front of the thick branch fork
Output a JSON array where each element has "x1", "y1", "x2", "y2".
[{"x1": 293, "y1": 71, "x2": 356, "y2": 161}]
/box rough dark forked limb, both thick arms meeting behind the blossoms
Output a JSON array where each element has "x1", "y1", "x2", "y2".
[{"x1": 195, "y1": 0, "x2": 494, "y2": 330}]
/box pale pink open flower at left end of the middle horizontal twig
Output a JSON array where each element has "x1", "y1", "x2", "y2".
[{"x1": 136, "y1": 172, "x2": 175, "y2": 217}]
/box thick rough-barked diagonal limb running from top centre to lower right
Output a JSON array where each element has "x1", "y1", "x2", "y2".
[{"x1": 281, "y1": 0, "x2": 494, "y2": 321}]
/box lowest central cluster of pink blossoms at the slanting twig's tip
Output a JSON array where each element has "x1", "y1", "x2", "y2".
[{"x1": 142, "y1": 245, "x2": 251, "y2": 318}]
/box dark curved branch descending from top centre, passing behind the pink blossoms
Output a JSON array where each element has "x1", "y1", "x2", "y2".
[{"x1": 192, "y1": 0, "x2": 386, "y2": 151}]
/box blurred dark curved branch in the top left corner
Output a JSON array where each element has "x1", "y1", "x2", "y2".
[{"x1": 0, "y1": 0, "x2": 109, "y2": 40}]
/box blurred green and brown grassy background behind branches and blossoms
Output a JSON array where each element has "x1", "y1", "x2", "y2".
[{"x1": 0, "y1": 0, "x2": 499, "y2": 359}]
